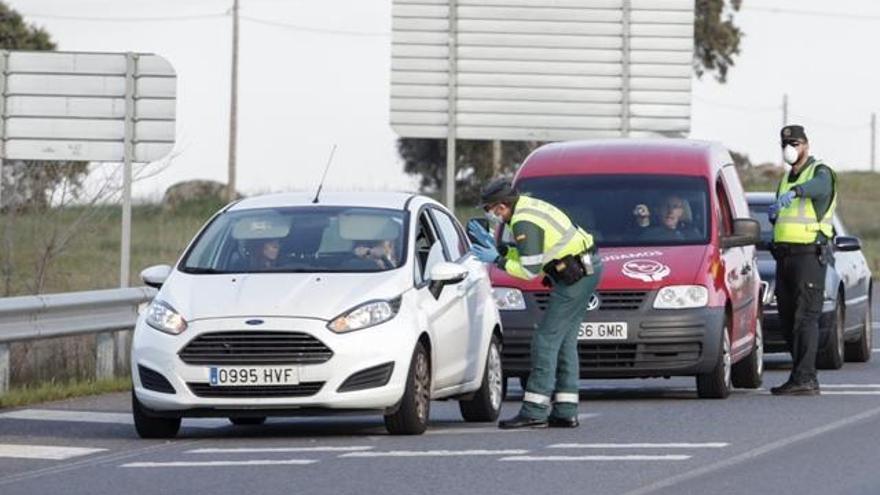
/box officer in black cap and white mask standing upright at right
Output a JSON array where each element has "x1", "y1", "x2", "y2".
[{"x1": 769, "y1": 125, "x2": 837, "y2": 395}]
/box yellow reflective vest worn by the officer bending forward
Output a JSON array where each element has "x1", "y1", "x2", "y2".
[{"x1": 504, "y1": 196, "x2": 593, "y2": 280}]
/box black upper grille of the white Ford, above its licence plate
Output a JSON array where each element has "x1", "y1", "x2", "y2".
[{"x1": 178, "y1": 331, "x2": 333, "y2": 365}]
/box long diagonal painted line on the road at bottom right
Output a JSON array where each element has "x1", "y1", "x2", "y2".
[{"x1": 625, "y1": 407, "x2": 880, "y2": 495}]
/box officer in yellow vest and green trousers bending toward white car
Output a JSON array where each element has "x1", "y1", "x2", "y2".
[{"x1": 468, "y1": 179, "x2": 602, "y2": 429}]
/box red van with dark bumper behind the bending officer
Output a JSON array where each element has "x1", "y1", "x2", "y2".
[{"x1": 491, "y1": 139, "x2": 763, "y2": 398}]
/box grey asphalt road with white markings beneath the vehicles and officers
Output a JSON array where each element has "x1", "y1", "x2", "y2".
[{"x1": 0, "y1": 298, "x2": 880, "y2": 495}]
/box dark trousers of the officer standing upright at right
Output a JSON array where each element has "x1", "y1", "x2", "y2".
[{"x1": 776, "y1": 253, "x2": 826, "y2": 383}]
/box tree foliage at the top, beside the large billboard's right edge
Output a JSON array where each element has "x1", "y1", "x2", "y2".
[{"x1": 694, "y1": 0, "x2": 743, "y2": 83}]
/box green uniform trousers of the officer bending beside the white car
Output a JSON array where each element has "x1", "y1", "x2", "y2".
[{"x1": 520, "y1": 256, "x2": 602, "y2": 419}]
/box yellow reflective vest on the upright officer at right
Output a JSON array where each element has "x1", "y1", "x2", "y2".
[{"x1": 773, "y1": 160, "x2": 837, "y2": 244}]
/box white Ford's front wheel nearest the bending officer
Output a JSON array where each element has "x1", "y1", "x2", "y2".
[{"x1": 385, "y1": 342, "x2": 431, "y2": 435}]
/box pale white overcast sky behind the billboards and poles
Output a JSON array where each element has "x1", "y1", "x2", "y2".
[{"x1": 7, "y1": 0, "x2": 880, "y2": 198}]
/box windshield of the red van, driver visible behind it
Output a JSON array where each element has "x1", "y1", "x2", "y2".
[{"x1": 517, "y1": 175, "x2": 709, "y2": 250}]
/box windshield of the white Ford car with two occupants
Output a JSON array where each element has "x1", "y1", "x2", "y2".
[{"x1": 180, "y1": 207, "x2": 406, "y2": 274}]
